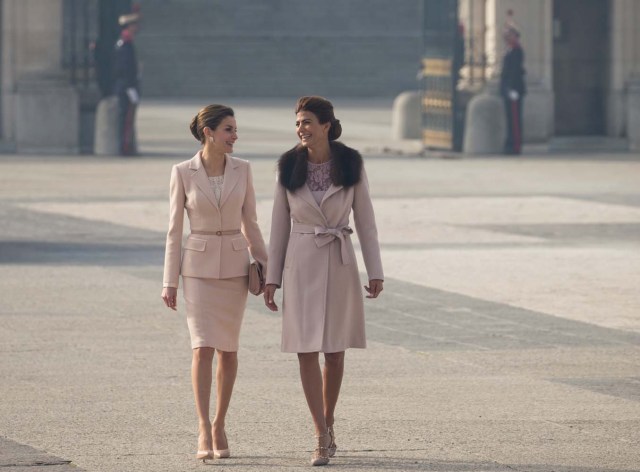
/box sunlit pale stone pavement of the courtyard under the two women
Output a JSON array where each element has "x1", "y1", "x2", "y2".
[{"x1": 0, "y1": 100, "x2": 640, "y2": 472}]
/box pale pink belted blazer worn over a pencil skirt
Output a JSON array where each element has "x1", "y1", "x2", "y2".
[{"x1": 163, "y1": 151, "x2": 267, "y2": 287}]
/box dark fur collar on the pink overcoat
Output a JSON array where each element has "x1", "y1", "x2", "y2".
[{"x1": 278, "y1": 141, "x2": 362, "y2": 192}]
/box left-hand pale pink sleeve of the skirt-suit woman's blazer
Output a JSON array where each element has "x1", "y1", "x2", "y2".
[{"x1": 162, "y1": 166, "x2": 186, "y2": 288}]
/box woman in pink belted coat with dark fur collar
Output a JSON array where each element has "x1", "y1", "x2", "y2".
[{"x1": 264, "y1": 97, "x2": 384, "y2": 465}]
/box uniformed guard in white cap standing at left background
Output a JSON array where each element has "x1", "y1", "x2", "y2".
[{"x1": 114, "y1": 13, "x2": 140, "y2": 156}]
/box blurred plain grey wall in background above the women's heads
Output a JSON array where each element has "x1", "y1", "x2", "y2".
[{"x1": 137, "y1": 0, "x2": 422, "y2": 97}]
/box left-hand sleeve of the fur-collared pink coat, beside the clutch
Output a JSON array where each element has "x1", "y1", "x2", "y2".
[{"x1": 267, "y1": 176, "x2": 291, "y2": 287}]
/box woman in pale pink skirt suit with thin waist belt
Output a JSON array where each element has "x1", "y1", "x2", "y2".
[{"x1": 162, "y1": 105, "x2": 267, "y2": 461}]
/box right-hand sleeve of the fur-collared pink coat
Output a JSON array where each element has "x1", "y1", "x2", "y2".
[{"x1": 352, "y1": 167, "x2": 384, "y2": 280}]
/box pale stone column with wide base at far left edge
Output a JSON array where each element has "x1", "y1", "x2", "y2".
[{"x1": 3, "y1": 0, "x2": 79, "y2": 153}]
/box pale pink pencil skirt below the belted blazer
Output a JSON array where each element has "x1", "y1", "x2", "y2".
[{"x1": 182, "y1": 275, "x2": 249, "y2": 352}]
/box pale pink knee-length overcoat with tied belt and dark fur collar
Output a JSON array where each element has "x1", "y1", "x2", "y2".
[{"x1": 267, "y1": 143, "x2": 384, "y2": 352}]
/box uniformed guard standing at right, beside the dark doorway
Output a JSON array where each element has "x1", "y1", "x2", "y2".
[{"x1": 500, "y1": 26, "x2": 527, "y2": 154}]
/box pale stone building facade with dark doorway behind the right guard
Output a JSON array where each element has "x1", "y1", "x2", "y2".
[{"x1": 459, "y1": 0, "x2": 640, "y2": 142}]
